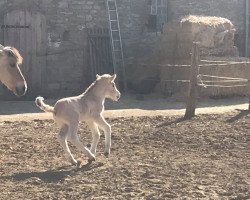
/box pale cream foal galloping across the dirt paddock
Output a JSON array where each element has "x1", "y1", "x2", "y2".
[{"x1": 35, "y1": 74, "x2": 121, "y2": 164}]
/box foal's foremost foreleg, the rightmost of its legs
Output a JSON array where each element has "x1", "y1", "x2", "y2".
[{"x1": 96, "y1": 116, "x2": 111, "y2": 156}]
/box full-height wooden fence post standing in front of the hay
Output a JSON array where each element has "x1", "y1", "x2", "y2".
[{"x1": 184, "y1": 42, "x2": 200, "y2": 119}]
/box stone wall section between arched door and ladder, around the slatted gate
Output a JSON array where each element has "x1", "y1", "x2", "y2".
[{"x1": 0, "y1": 0, "x2": 108, "y2": 96}]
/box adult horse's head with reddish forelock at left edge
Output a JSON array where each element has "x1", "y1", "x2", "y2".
[{"x1": 0, "y1": 45, "x2": 27, "y2": 96}]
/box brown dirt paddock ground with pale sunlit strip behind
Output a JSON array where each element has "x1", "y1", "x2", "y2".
[{"x1": 0, "y1": 96, "x2": 250, "y2": 200}]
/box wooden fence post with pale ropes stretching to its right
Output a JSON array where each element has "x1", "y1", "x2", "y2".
[{"x1": 184, "y1": 43, "x2": 250, "y2": 119}]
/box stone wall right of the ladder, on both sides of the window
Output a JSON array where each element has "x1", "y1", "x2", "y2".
[{"x1": 117, "y1": 0, "x2": 245, "y2": 62}]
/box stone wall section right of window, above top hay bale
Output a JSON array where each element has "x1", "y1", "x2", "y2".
[{"x1": 168, "y1": 0, "x2": 245, "y2": 55}]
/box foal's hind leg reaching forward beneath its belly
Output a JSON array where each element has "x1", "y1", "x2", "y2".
[{"x1": 69, "y1": 121, "x2": 95, "y2": 162}]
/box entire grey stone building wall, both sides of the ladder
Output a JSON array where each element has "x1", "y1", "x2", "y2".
[{"x1": 0, "y1": 0, "x2": 245, "y2": 95}]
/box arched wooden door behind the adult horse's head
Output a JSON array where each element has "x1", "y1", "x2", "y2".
[{"x1": 0, "y1": 10, "x2": 46, "y2": 98}]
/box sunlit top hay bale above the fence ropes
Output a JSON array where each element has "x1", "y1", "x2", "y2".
[{"x1": 158, "y1": 15, "x2": 239, "y2": 61}]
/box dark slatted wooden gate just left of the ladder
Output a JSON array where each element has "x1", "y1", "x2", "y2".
[{"x1": 87, "y1": 28, "x2": 114, "y2": 80}]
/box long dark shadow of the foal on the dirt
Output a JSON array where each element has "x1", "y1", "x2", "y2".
[{"x1": 0, "y1": 162, "x2": 104, "y2": 183}]
